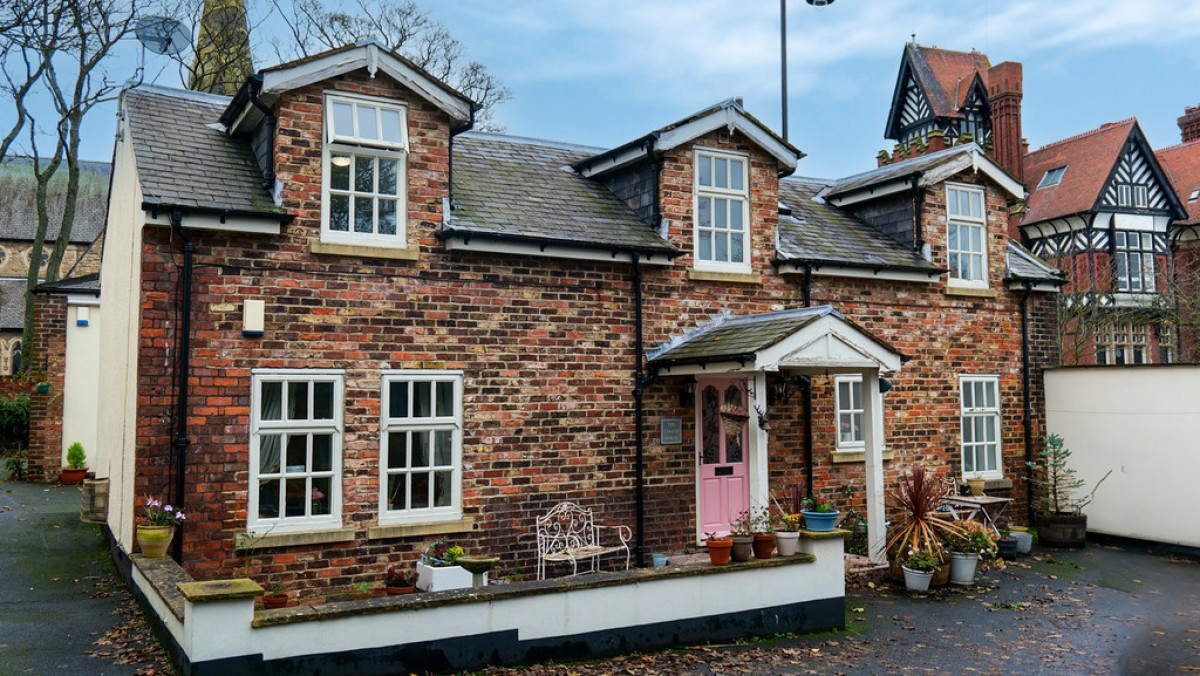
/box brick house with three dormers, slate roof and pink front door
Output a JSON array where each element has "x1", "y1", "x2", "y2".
[{"x1": 87, "y1": 43, "x2": 1061, "y2": 600}]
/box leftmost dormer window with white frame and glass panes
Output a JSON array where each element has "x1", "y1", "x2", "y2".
[{"x1": 320, "y1": 95, "x2": 408, "y2": 247}]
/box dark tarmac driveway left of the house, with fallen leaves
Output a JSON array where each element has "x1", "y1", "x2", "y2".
[{"x1": 0, "y1": 471, "x2": 170, "y2": 676}]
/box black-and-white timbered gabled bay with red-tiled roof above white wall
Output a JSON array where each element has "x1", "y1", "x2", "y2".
[{"x1": 1020, "y1": 119, "x2": 1187, "y2": 364}]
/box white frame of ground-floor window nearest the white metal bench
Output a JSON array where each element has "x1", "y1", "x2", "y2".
[{"x1": 378, "y1": 369, "x2": 464, "y2": 525}]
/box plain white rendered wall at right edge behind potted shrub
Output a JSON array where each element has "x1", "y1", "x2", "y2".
[{"x1": 1045, "y1": 366, "x2": 1200, "y2": 546}]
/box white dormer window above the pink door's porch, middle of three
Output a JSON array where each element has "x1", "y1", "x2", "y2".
[{"x1": 694, "y1": 149, "x2": 750, "y2": 273}]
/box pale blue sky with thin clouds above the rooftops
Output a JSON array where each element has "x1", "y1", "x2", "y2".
[{"x1": 16, "y1": 0, "x2": 1200, "y2": 178}]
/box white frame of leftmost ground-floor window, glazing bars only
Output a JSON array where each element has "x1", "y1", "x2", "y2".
[{"x1": 246, "y1": 369, "x2": 346, "y2": 534}]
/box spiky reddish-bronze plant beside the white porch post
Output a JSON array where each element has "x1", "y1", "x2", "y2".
[{"x1": 887, "y1": 466, "x2": 959, "y2": 585}]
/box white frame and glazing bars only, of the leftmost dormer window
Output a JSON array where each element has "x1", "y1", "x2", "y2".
[{"x1": 320, "y1": 91, "x2": 408, "y2": 249}]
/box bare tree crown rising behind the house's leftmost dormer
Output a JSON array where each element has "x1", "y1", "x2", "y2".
[{"x1": 272, "y1": 0, "x2": 512, "y2": 131}]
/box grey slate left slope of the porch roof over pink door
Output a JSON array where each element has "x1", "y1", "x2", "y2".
[{"x1": 648, "y1": 305, "x2": 845, "y2": 366}]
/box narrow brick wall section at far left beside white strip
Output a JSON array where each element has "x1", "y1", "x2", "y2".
[{"x1": 28, "y1": 293, "x2": 67, "y2": 483}]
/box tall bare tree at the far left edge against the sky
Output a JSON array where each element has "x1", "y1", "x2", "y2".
[{"x1": 0, "y1": 0, "x2": 136, "y2": 364}]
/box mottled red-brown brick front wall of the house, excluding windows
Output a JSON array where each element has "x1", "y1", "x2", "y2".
[{"x1": 126, "y1": 76, "x2": 1056, "y2": 598}]
